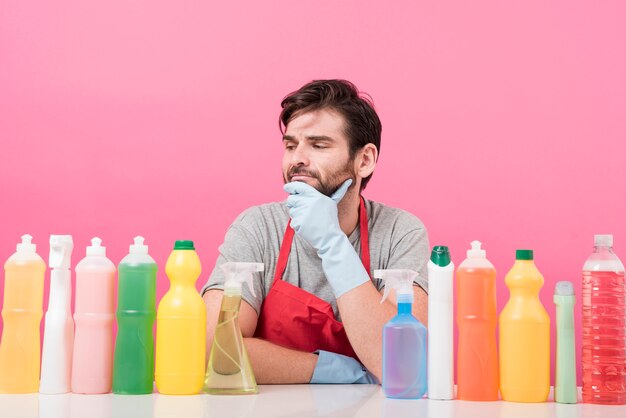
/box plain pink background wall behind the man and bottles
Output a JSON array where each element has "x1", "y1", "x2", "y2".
[{"x1": 0, "y1": 0, "x2": 626, "y2": 384}]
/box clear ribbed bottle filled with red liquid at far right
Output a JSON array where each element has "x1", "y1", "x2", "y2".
[{"x1": 582, "y1": 235, "x2": 626, "y2": 405}]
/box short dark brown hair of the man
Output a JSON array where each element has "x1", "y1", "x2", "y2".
[{"x1": 278, "y1": 80, "x2": 382, "y2": 190}]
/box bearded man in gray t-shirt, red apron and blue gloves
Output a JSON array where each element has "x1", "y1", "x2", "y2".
[{"x1": 203, "y1": 80, "x2": 429, "y2": 384}]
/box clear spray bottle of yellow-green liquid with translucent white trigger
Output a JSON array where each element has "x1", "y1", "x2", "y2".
[{"x1": 204, "y1": 262, "x2": 263, "y2": 395}]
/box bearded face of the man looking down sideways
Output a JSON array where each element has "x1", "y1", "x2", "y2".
[{"x1": 283, "y1": 109, "x2": 356, "y2": 196}]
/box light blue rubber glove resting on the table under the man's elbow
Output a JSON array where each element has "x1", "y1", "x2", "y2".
[{"x1": 310, "y1": 350, "x2": 378, "y2": 384}]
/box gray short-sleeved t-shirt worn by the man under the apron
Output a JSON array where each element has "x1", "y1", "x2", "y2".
[{"x1": 202, "y1": 199, "x2": 429, "y2": 319}]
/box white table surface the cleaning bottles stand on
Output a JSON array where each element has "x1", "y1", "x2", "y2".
[{"x1": 0, "y1": 385, "x2": 626, "y2": 418}]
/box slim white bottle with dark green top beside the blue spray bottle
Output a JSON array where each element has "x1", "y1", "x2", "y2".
[{"x1": 428, "y1": 245, "x2": 454, "y2": 400}]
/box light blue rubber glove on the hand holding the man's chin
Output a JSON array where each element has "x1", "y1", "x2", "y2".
[{"x1": 284, "y1": 179, "x2": 370, "y2": 298}]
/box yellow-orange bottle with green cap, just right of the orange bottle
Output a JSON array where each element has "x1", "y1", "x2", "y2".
[{"x1": 500, "y1": 250, "x2": 550, "y2": 402}]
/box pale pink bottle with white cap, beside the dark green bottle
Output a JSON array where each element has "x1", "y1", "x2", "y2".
[{"x1": 72, "y1": 238, "x2": 116, "y2": 393}]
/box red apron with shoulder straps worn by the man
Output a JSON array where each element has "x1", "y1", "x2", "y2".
[{"x1": 254, "y1": 197, "x2": 371, "y2": 359}]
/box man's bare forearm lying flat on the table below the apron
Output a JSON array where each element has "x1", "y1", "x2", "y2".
[{"x1": 243, "y1": 338, "x2": 317, "y2": 385}]
